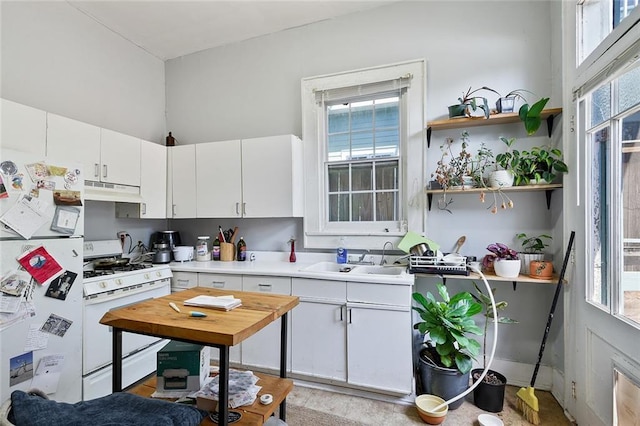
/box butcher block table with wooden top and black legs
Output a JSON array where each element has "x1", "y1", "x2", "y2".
[{"x1": 100, "y1": 287, "x2": 299, "y2": 425}]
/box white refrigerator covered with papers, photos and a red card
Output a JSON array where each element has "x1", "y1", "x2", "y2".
[{"x1": 0, "y1": 149, "x2": 84, "y2": 403}]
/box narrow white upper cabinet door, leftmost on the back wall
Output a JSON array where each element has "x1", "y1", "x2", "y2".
[{"x1": 167, "y1": 145, "x2": 196, "y2": 219}]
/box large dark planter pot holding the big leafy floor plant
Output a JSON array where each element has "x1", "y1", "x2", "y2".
[{"x1": 419, "y1": 348, "x2": 469, "y2": 410}]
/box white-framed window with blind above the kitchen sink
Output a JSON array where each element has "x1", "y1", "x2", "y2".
[{"x1": 302, "y1": 60, "x2": 426, "y2": 250}]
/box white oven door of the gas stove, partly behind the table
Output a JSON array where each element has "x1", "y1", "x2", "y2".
[{"x1": 82, "y1": 279, "x2": 171, "y2": 376}]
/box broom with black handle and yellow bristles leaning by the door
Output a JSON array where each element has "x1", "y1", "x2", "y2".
[{"x1": 516, "y1": 231, "x2": 576, "y2": 425}]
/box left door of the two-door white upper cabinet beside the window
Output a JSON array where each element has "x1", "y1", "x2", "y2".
[{"x1": 196, "y1": 140, "x2": 242, "y2": 218}]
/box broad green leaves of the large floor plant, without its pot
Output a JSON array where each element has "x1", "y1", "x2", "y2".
[{"x1": 412, "y1": 283, "x2": 482, "y2": 374}]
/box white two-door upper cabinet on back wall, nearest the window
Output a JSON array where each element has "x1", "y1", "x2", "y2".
[{"x1": 196, "y1": 135, "x2": 303, "y2": 218}]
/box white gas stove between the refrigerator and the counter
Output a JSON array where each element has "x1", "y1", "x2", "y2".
[{"x1": 82, "y1": 240, "x2": 172, "y2": 401}]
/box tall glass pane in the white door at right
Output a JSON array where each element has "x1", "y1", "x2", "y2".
[{"x1": 579, "y1": 64, "x2": 640, "y2": 325}]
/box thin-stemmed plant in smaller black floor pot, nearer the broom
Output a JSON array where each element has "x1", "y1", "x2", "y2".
[{"x1": 471, "y1": 281, "x2": 518, "y2": 413}]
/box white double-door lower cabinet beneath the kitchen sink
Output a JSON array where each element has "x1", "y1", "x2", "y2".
[{"x1": 291, "y1": 278, "x2": 413, "y2": 395}]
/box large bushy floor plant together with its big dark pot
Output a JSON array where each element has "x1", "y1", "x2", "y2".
[{"x1": 412, "y1": 283, "x2": 482, "y2": 410}]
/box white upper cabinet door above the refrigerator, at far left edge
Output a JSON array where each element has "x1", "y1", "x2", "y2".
[{"x1": 0, "y1": 99, "x2": 47, "y2": 158}]
